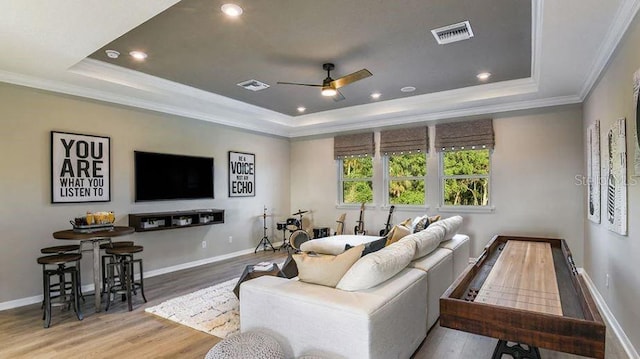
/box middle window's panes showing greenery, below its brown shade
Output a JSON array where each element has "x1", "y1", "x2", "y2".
[{"x1": 384, "y1": 152, "x2": 427, "y2": 206}]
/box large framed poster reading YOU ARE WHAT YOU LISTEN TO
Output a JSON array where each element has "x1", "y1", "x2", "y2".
[{"x1": 51, "y1": 131, "x2": 111, "y2": 203}]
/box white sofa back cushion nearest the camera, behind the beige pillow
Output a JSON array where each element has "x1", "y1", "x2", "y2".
[{"x1": 336, "y1": 241, "x2": 416, "y2": 291}]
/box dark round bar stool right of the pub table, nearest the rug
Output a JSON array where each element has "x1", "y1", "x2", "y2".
[{"x1": 105, "y1": 245, "x2": 147, "y2": 311}]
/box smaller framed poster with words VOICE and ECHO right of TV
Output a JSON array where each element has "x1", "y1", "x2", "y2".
[{"x1": 229, "y1": 151, "x2": 256, "y2": 197}]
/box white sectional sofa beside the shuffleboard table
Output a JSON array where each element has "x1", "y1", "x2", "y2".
[{"x1": 240, "y1": 217, "x2": 469, "y2": 359}]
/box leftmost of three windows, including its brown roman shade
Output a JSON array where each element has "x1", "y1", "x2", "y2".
[{"x1": 333, "y1": 132, "x2": 375, "y2": 204}]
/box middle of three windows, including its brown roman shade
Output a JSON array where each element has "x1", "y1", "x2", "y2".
[{"x1": 380, "y1": 126, "x2": 429, "y2": 207}]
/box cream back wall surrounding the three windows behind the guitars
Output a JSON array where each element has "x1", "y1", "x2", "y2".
[{"x1": 291, "y1": 106, "x2": 584, "y2": 265}]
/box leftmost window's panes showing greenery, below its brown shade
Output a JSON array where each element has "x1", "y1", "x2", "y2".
[{"x1": 338, "y1": 156, "x2": 373, "y2": 204}]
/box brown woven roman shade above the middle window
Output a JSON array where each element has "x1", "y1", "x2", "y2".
[{"x1": 380, "y1": 126, "x2": 429, "y2": 155}]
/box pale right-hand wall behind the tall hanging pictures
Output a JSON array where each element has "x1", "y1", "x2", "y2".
[{"x1": 584, "y1": 10, "x2": 640, "y2": 349}]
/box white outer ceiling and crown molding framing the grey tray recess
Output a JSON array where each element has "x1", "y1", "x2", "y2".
[{"x1": 0, "y1": 0, "x2": 640, "y2": 137}]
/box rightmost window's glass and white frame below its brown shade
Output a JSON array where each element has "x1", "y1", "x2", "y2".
[{"x1": 440, "y1": 149, "x2": 491, "y2": 206}]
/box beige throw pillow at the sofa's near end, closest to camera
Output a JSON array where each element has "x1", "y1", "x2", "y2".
[{"x1": 293, "y1": 244, "x2": 364, "y2": 287}]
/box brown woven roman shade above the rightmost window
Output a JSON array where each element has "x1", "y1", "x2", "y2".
[{"x1": 435, "y1": 119, "x2": 495, "y2": 152}]
